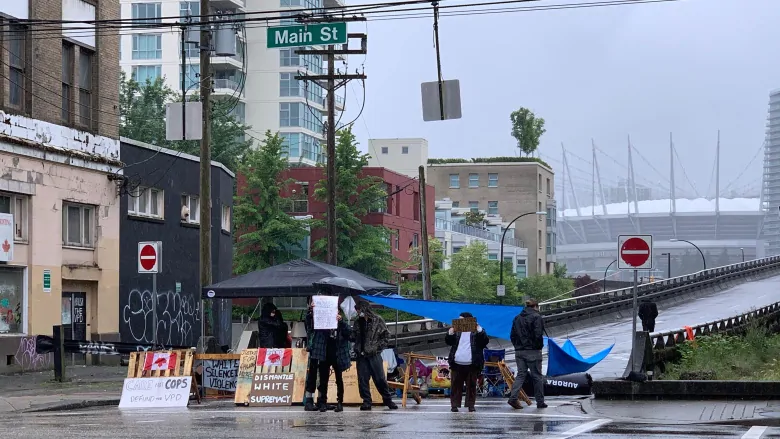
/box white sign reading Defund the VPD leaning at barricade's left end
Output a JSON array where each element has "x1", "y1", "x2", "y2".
[{"x1": 119, "y1": 377, "x2": 192, "y2": 409}]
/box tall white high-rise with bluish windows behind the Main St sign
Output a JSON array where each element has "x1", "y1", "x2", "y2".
[{"x1": 120, "y1": 0, "x2": 345, "y2": 166}]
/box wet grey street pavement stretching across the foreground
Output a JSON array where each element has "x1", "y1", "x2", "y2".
[{"x1": 0, "y1": 401, "x2": 780, "y2": 439}]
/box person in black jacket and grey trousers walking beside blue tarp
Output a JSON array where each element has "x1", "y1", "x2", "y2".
[{"x1": 507, "y1": 299, "x2": 547, "y2": 409}]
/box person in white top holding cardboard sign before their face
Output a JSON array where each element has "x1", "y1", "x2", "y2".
[{"x1": 444, "y1": 312, "x2": 490, "y2": 412}]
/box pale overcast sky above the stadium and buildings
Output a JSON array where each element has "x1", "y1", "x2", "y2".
[{"x1": 343, "y1": 0, "x2": 780, "y2": 205}]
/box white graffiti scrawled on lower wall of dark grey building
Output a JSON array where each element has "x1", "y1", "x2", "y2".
[{"x1": 120, "y1": 289, "x2": 201, "y2": 346}]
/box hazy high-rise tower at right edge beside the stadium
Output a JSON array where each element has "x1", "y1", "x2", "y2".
[{"x1": 761, "y1": 89, "x2": 780, "y2": 256}]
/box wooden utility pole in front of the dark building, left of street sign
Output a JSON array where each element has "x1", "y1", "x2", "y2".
[{"x1": 200, "y1": 0, "x2": 213, "y2": 342}]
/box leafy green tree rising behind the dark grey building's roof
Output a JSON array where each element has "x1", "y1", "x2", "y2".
[{"x1": 119, "y1": 72, "x2": 252, "y2": 172}]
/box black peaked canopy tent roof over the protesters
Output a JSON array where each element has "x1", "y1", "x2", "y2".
[{"x1": 201, "y1": 259, "x2": 398, "y2": 299}]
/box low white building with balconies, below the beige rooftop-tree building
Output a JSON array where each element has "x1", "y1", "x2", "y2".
[{"x1": 436, "y1": 198, "x2": 528, "y2": 278}]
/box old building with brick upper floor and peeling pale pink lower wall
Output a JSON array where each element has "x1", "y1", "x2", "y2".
[{"x1": 0, "y1": 0, "x2": 122, "y2": 372}]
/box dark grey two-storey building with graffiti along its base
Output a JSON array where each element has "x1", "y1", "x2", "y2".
[{"x1": 119, "y1": 138, "x2": 235, "y2": 346}]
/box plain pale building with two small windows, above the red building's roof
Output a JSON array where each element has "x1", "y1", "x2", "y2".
[{"x1": 368, "y1": 138, "x2": 428, "y2": 178}]
